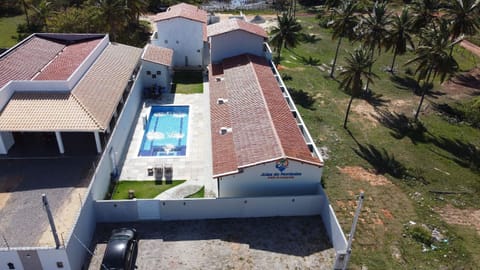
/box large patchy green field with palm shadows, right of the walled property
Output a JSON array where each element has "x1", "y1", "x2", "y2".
[{"x1": 279, "y1": 12, "x2": 480, "y2": 269}]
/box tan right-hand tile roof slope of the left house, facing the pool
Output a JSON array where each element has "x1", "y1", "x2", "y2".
[{"x1": 72, "y1": 43, "x2": 142, "y2": 129}]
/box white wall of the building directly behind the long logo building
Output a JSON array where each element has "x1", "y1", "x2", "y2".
[{"x1": 210, "y1": 30, "x2": 265, "y2": 63}]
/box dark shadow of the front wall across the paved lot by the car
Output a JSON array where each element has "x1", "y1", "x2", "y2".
[{"x1": 95, "y1": 216, "x2": 332, "y2": 257}]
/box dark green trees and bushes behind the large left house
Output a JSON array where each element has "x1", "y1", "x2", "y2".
[{"x1": 0, "y1": 0, "x2": 202, "y2": 46}]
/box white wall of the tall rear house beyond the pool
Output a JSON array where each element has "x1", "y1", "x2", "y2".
[{"x1": 152, "y1": 18, "x2": 204, "y2": 68}]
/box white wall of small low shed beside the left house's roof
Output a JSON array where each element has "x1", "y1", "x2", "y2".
[{"x1": 141, "y1": 60, "x2": 171, "y2": 91}]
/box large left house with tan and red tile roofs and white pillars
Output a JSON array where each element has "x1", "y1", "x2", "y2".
[{"x1": 0, "y1": 34, "x2": 142, "y2": 154}]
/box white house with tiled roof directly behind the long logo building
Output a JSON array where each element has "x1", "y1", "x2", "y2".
[{"x1": 207, "y1": 19, "x2": 268, "y2": 63}]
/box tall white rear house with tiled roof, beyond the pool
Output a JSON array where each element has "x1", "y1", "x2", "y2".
[{"x1": 152, "y1": 3, "x2": 207, "y2": 69}]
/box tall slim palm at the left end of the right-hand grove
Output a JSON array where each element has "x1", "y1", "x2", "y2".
[{"x1": 328, "y1": 1, "x2": 358, "y2": 78}]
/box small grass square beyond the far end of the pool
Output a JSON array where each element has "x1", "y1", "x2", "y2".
[{"x1": 172, "y1": 71, "x2": 203, "y2": 94}]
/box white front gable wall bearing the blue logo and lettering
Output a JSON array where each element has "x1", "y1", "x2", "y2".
[{"x1": 218, "y1": 160, "x2": 322, "y2": 197}]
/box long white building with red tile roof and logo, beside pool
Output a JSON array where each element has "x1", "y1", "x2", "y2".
[{"x1": 210, "y1": 54, "x2": 323, "y2": 197}]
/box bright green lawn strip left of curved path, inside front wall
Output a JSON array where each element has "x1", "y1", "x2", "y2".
[{"x1": 112, "y1": 180, "x2": 185, "y2": 200}]
